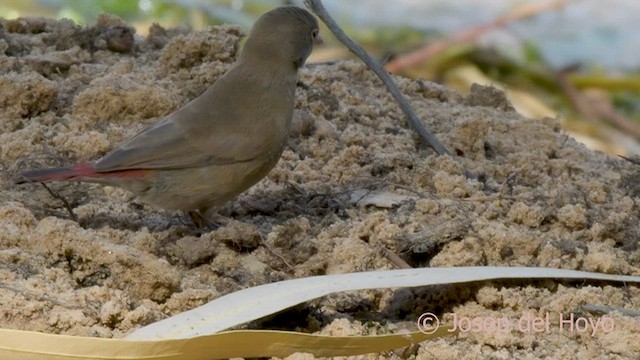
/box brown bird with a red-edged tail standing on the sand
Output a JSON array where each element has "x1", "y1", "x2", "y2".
[{"x1": 15, "y1": 6, "x2": 322, "y2": 228}]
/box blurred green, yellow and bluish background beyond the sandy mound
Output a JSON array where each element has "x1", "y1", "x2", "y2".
[{"x1": 0, "y1": 0, "x2": 640, "y2": 155}]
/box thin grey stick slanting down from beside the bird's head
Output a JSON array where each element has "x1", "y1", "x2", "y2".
[{"x1": 305, "y1": 0, "x2": 476, "y2": 179}]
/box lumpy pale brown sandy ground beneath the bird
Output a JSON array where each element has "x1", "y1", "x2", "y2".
[{"x1": 0, "y1": 12, "x2": 640, "y2": 359}]
